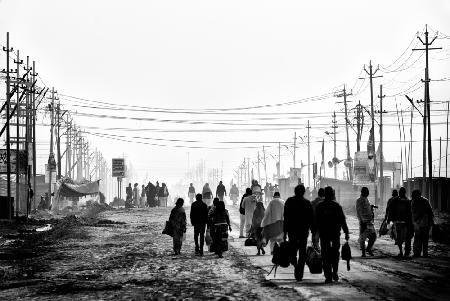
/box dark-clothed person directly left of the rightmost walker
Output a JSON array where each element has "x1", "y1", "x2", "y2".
[{"x1": 386, "y1": 187, "x2": 412, "y2": 257}]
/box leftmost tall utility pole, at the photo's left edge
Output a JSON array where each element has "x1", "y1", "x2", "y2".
[{"x1": 3, "y1": 32, "x2": 13, "y2": 219}]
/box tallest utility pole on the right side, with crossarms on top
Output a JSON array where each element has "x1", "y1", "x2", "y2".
[{"x1": 413, "y1": 25, "x2": 442, "y2": 201}]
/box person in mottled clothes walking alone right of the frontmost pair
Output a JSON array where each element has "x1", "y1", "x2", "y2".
[{"x1": 356, "y1": 187, "x2": 377, "y2": 257}]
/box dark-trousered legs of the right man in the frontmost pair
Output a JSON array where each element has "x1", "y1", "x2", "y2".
[{"x1": 320, "y1": 236, "x2": 341, "y2": 283}]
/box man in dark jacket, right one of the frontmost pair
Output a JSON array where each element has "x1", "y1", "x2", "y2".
[{"x1": 316, "y1": 186, "x2": 349, "y2": 283}]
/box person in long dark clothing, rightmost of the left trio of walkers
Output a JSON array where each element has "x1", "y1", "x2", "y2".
[{"x1": 211, "y1": 201, "x2": 231, "y2": 258}]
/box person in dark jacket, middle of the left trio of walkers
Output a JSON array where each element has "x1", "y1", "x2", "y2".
[{"x1": 190, "y1": 193, "x2": 208, "y2": 256}]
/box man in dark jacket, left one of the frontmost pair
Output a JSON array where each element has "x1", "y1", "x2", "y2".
[{"x1": 283, "y1": 185, "x2": 313, "y2": 281}]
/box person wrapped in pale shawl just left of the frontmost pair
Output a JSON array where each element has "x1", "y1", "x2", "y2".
[{"x1": 261, "y1": 192, "x2": 284, "y2": 254}]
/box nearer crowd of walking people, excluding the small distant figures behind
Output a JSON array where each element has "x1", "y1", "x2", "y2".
[{"x1": 161, "y1": 181, "x2": 434, "y2": 283}]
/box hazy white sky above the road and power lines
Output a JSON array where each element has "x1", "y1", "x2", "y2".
[{"x1": 0, "y1": 0, "x2": 450, "y2": 190}]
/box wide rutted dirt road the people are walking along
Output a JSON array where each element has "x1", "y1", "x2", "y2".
[{"x1": 0, "y1": 206, "x2": 450, "y2": 300}]
